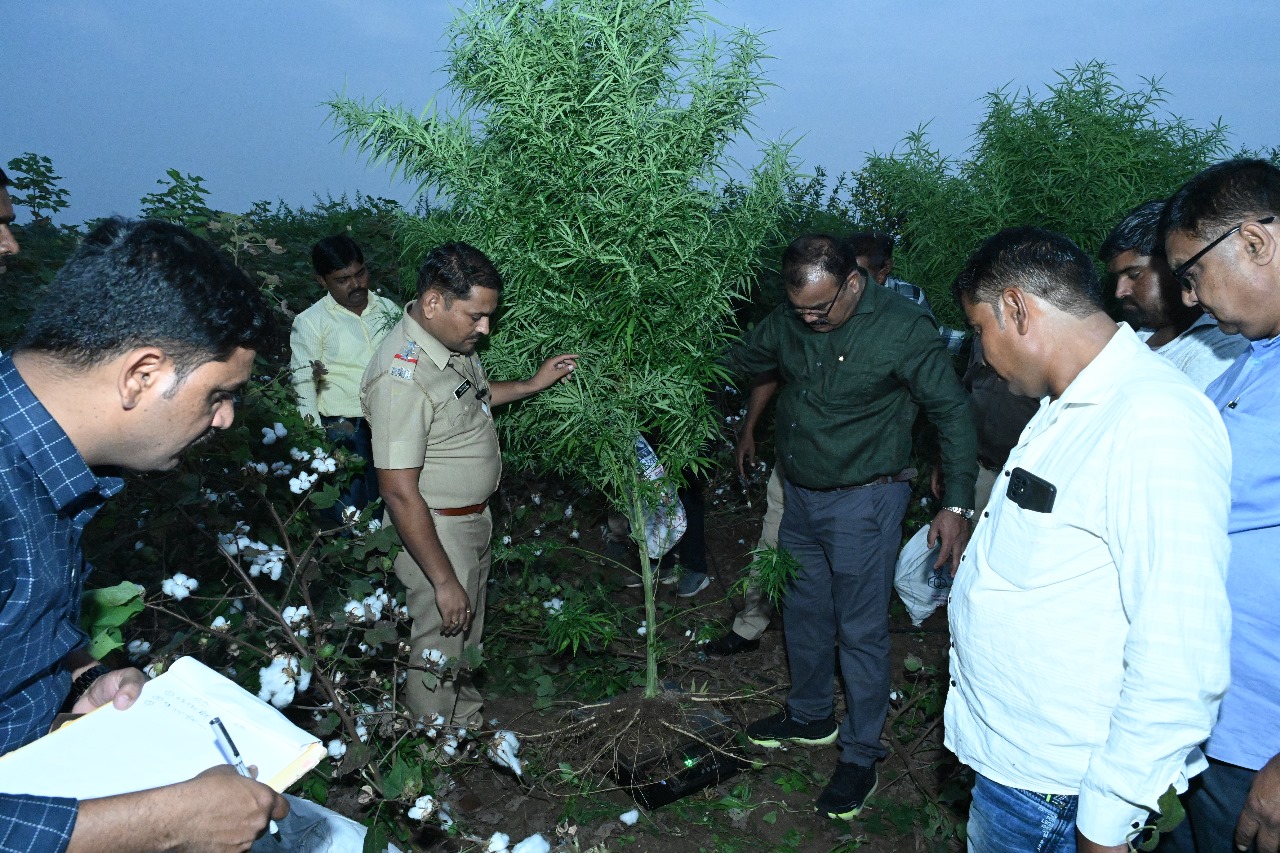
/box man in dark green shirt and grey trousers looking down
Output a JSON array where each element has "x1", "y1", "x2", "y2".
[{"x1": 730, "y1": 234, "x2": 977, "y2": 820}]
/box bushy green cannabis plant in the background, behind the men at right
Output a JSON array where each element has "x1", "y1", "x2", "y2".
[{"x1": 854, "y1": 61, "x2": 1228, "y2": 325}]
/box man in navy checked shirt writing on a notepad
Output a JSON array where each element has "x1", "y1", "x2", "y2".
[{"x1": 0, "y1": 204, "x2": 362, "y2": 852}]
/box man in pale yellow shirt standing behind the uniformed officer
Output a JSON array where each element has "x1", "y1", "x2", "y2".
[{"x1": 289, "y1": 234, "x2": 403, "y2": 510}]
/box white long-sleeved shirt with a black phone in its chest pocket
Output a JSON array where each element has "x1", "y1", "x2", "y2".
[{"x1": 946, "y1": 325, "x2": 1231, "y2": 844}]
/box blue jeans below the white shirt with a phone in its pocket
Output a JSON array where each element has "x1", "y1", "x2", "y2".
[{"x1": 969, "y1": 774, "x2": 1078, "y2": 853}]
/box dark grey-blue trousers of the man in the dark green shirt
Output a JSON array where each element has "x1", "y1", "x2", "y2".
[{"x1": 778, "y1": 482, "x2": 911, "y2": 766}]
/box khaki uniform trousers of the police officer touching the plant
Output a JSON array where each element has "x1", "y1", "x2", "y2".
[{"x1": 396, "y1": 508, "x2": 493, "y2": 727}]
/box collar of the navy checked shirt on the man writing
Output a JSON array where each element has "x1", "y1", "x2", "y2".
[{"x1": 0, "y1": 353, "x2": 124, "y2": 512}]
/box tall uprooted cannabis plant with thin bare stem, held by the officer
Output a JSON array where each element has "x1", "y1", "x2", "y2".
[{"x1": 330, "y1": 0, "x2": 791, "y2": 695}]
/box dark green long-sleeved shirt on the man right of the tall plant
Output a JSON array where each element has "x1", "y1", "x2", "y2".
[{"x1": 728, "y1": 280, "x2": 978, "y2": 508}]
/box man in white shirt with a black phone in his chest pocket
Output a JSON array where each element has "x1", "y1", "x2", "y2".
[{"x1": 946, "y1": 222, "x2": 1231, "y2": 853}]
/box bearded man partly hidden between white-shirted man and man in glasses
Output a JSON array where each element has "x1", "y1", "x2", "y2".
[{"x1": 1098, "y1": 200, "x2": 1249, "y2": 388}]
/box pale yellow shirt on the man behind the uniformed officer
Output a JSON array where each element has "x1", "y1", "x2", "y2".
[{"x1": 289, "y1": 293, "x2": 402, "y2": 424}]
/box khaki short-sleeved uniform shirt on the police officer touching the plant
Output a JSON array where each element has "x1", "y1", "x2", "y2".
[{"x1": 360, "y1": 313, "x2": 502, "y2": 510}]
